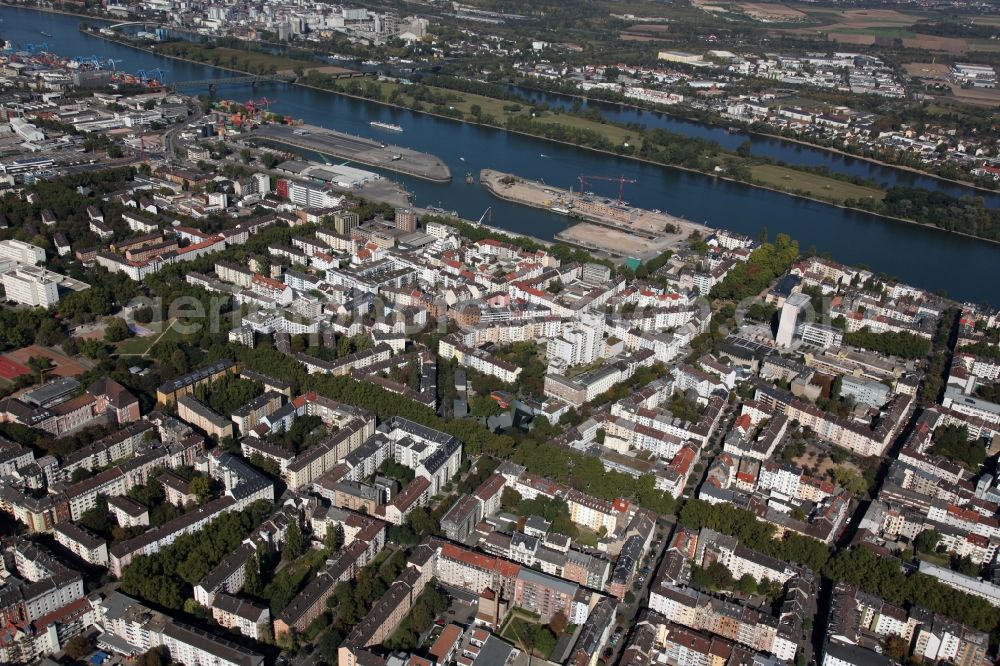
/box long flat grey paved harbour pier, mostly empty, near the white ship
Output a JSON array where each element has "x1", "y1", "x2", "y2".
[{"x1": 251, "y1": 125, "x2": 451, "y2": 183}]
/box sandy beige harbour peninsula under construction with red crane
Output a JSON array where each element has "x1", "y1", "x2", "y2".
[{"x1": 479, "y1": 169, "x2": 711, "y2": 259}]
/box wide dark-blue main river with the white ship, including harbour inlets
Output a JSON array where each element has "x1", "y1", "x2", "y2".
[{"x1": 0, "y1": 7, "x2": 1000, "y2": 305}]
